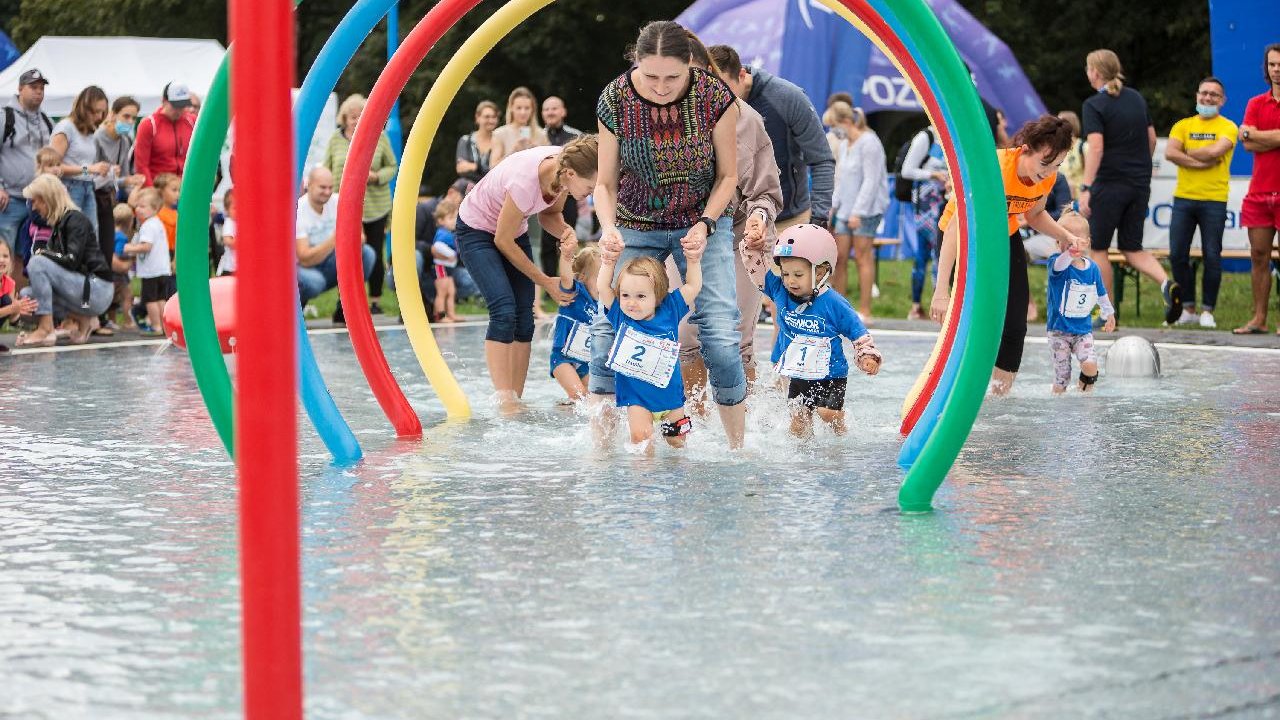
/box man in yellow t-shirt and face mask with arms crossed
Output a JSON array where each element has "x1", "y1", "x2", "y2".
[{"x1": 1165, "y1": 77, "x2": 1238, "y2": 328}]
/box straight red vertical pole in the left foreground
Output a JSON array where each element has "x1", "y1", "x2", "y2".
[{"x1": 230, "y1": 0, "x2": 302, "y2": 720}]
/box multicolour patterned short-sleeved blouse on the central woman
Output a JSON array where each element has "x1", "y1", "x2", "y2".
[{"x1": 595, "y1": 68, "x2": 733, "y2": 231}]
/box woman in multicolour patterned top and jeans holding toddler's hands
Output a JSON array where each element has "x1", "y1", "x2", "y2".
[{"x1": 589, "y1": 20, "x2": 746, "y2": 447}]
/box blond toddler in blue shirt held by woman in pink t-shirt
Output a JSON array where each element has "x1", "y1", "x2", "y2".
[{"x1": 547, "y1": 237, "x2": 600, "y2": 404}]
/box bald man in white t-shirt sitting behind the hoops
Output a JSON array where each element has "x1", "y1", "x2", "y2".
[{"x1": 294, "y1": 165, "x2": 375, "y2": 325}]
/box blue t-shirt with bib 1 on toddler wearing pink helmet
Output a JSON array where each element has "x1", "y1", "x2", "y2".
[{"x1": 764, "y1": 273, "x2": 867, "y2": 380}]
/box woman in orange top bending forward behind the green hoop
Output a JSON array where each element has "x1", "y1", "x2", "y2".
[{"x1": 929, "y1": 115, "x2": 1076, "y2": 395}]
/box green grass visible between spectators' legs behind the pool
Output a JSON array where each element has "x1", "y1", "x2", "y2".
[{"x1": 294, "y1": 260, "x2": 1253, "y2": 332}]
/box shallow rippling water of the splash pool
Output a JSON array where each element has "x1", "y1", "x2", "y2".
[{"x1": 0, "y1": 327, "x2": 1280, "y2": 719}]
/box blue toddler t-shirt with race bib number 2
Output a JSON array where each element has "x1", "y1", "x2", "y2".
[{"x1": 607, "y1": 290, "x2": 689, "y2": 413}]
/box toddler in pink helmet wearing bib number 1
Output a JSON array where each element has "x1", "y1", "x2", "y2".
[{"x1": 741, "y1": 224, "x2": 882, "y2": 437}]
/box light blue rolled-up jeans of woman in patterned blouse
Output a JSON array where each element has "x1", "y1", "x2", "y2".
[{"x1": 586, "y1": 217, "x2": 746, "y2": 405}]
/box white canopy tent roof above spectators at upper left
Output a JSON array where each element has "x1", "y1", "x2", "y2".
[{"x1": 0, "y1": 36, "x2": 227, "y2": 118}]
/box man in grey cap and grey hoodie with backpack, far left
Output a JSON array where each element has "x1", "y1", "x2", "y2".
[{"x1": 0, "y1": 68, "x2": 54, "y2": 282}]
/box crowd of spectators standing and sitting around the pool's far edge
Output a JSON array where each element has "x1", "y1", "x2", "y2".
[{"x1": 0, "y1": 45, "x2": 1280, "y2": 345}]
